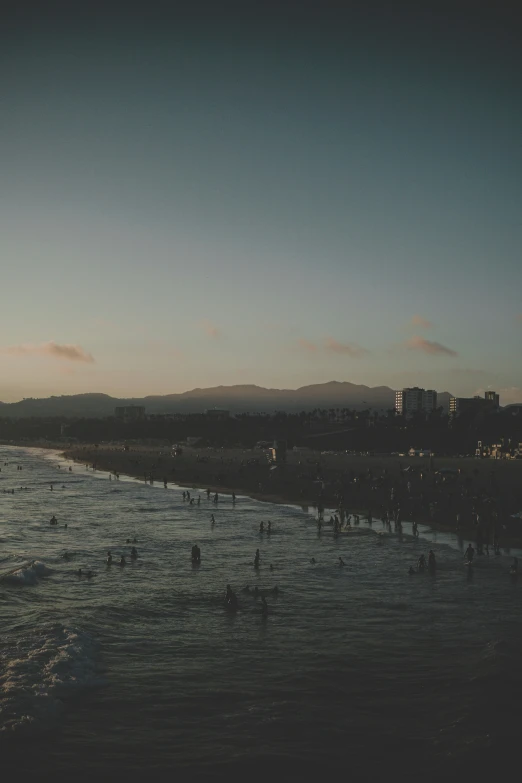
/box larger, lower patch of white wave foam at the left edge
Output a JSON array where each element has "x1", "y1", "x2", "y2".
[{"x1": 0, "y1": 627, "x2": 103, "y2": 732}]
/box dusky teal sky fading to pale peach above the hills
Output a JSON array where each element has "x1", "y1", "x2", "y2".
[{"x1": 0, "y1": 0, "x2": 522, "y2": 404}]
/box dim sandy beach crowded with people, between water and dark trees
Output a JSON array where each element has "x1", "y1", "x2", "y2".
[{"x1": 65, "y1": 444, "x2": 522, "y2": 546}]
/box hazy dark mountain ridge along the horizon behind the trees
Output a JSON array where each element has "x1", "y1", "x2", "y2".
[{"x1": 0, "y1": 381, "x2": 450, "y2": 418}]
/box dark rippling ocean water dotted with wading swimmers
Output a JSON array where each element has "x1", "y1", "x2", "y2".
[{"x1": 0, "y1": 447, "x2": 522, "y2": 780}]
